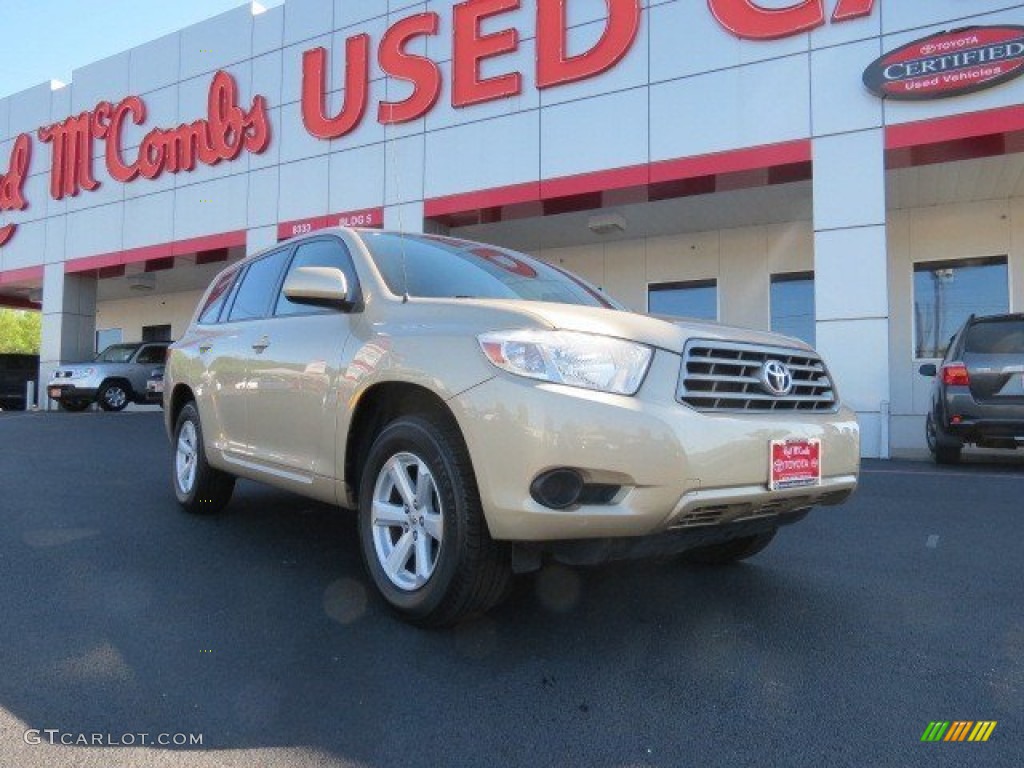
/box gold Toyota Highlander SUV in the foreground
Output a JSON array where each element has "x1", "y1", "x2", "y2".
[{"x1": 164, "y1": 229, "x2": 859, "y2": 626}]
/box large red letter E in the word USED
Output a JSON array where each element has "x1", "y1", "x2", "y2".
[{"x1": 452, "y1": 0, "x2": 522, "y2": 108}]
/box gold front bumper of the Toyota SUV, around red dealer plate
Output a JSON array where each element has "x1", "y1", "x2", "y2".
[{"x1": 450, "y1": 358, "x2": 860, "y2": 542}]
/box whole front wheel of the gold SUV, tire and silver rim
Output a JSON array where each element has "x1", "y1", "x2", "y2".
[{"x1": 359, "y1": 417, "x2": 512, "y2": 627}]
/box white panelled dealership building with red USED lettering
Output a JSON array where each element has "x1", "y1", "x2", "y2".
[{"x1": 0, "y1": 0, "x2": 1024, "y2": 456}]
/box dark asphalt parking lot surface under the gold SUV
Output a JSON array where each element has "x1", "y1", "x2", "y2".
[{"x1": 0, "y1": 413, "x2": 1024, "y2": 768}]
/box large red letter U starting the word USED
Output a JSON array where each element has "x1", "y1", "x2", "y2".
[{"x1": 302, "y1": 35, "x2": 370, "y2": 138}]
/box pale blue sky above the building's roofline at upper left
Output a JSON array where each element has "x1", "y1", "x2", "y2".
[{"x1": 0, "y1": 0, "x2": 283, "y2": 98}]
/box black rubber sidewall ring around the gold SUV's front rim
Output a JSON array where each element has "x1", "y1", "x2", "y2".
[{"x1": 359, "y1": 417, "x2": 471, "y2": 618}]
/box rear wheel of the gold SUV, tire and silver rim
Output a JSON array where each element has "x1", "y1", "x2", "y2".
[{"x1": 172, "y1": 402, "x2": 234, "y2": 515}]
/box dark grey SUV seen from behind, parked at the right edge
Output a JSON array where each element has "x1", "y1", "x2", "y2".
[{"x1": 920, "y1": 314, "x2": 1024, "y2": 464}]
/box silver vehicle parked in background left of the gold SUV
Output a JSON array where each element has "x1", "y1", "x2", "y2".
[{"x1": 46, "y1": 341, "x2": 170, "y2": 411}]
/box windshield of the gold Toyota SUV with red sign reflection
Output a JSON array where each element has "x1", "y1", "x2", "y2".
[{"x1": 360, "y1": 231, "x2": 622, "y2": 309}]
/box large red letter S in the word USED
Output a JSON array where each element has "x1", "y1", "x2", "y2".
[{"x1": 377, "y1": 13, "x2": 441, "y2": 125}]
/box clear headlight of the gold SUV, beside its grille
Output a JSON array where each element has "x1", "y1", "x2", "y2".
[{"x1": 477, "y1": 330, "x2": 653, "y2": 394}]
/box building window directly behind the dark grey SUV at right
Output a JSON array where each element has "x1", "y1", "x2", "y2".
[{"x1": 913, "y1": 256, "x2": 1010, "y2": 357}]
